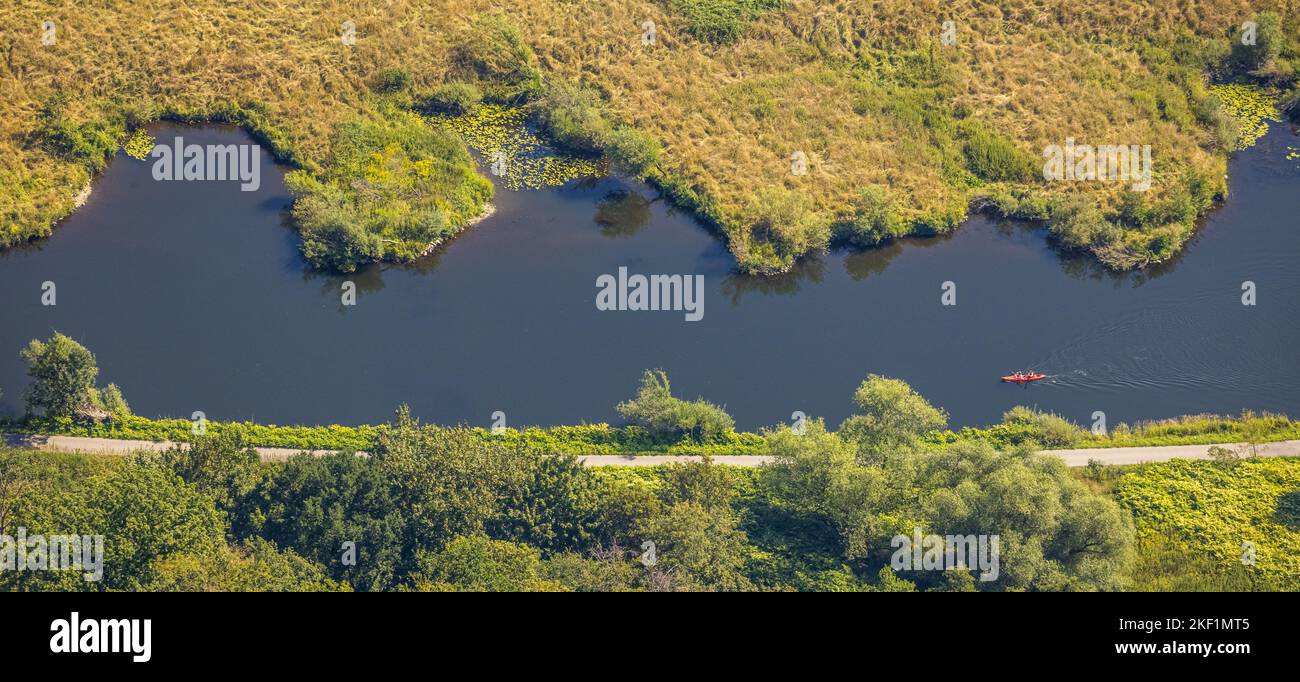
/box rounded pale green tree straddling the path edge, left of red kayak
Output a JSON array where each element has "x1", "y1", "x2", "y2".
[{"x1": 840, "y1": 374, "x2": 948, "y2": 460}]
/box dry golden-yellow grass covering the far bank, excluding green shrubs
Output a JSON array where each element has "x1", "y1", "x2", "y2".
[{"x1": 0, "y1": 0, "x2": 1294, "y2": 268}]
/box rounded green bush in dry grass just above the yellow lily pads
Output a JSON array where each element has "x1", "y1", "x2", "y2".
[{"x1": 451, "y1": 14, "x2": 542, "y2": 104}]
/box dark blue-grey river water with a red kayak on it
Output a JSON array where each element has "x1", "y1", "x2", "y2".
[{"x1": 0, "y1": 125, "x2": 1300, "y2": 427}]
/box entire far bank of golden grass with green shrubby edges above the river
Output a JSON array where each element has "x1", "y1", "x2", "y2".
[{"x1": 0, "y1": 0, "x2": 1300, "y2": 272}]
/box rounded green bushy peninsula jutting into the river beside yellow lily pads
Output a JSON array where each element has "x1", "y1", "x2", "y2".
[{"x1": 285, "y1": 108, "x2": 493, "y2": 273}]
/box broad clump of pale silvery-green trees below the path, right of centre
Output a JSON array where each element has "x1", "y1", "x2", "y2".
[{"x1": 763, "y1": 423, "x2": 1132, "y2": 590}]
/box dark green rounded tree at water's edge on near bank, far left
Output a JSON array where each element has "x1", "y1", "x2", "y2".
[{"x1": 18, "y1": 333, "x2": 99, "y2": 417}]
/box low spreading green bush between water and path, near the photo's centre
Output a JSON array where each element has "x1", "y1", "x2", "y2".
[{"x1": 618, "y1": 369, "x2": 736, "y2": 444}]
